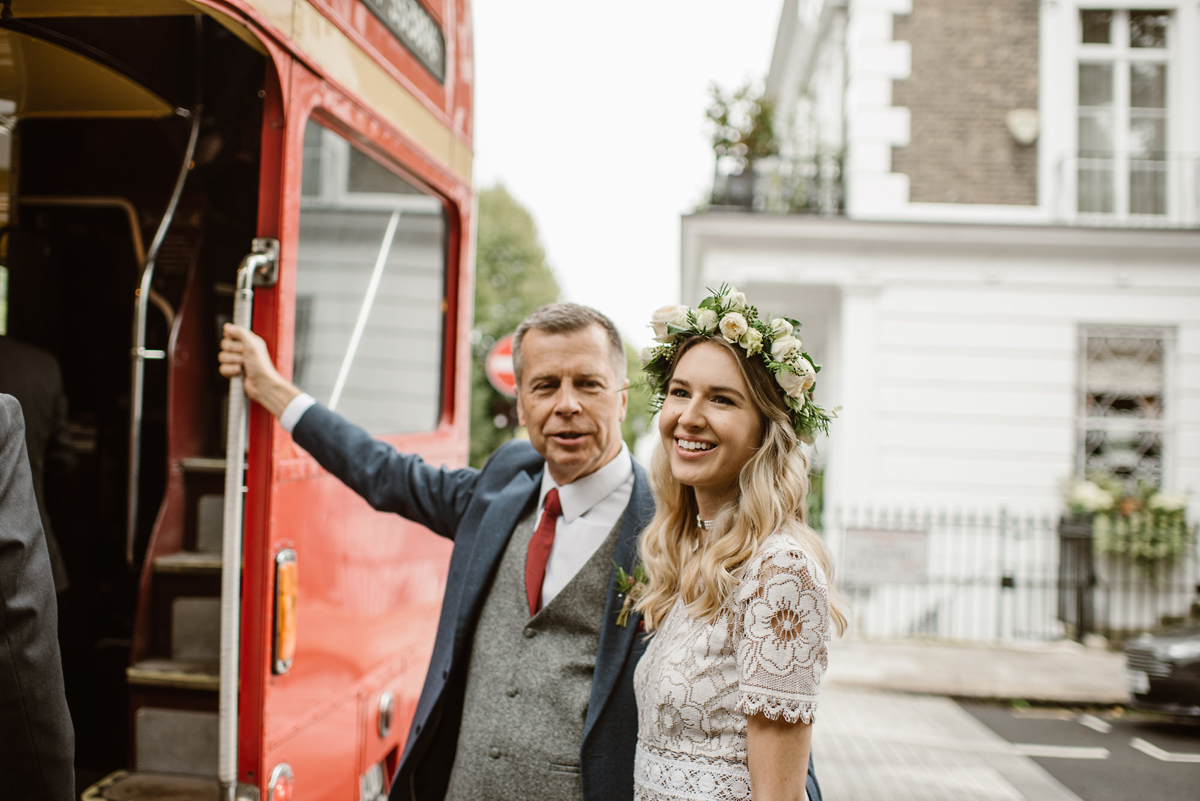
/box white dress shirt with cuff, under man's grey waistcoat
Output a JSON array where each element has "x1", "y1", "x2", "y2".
[{"x1": 280, "y1": 392, "x2": 634, "y2": 606}]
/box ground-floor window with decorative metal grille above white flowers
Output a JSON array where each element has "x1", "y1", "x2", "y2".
[{"x1": 1076, "y1": 326, "x2": 1174, "y2": 490}]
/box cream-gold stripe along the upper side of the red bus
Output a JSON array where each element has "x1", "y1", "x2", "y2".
[{"x1": 246, "y1": 0, "x2": 472, "y2": 181}]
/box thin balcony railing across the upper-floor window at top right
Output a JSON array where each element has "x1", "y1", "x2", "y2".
[{"x1": 1052, "y1": 152, "x2": 1200, "y2": 228}]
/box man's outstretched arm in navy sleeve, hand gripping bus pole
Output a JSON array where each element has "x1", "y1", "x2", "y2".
[{"x1": 217, "y1": 324, "x2": 479, "y2": 540}]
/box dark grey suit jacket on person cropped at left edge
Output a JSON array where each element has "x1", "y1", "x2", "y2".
[{"x1": 0, "y1": 395, "x2": 74, "y2": 801}]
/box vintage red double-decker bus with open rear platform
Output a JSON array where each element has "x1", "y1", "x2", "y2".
[{"x1": 0, "y1": 0, "x2": 473, "y2": 801}]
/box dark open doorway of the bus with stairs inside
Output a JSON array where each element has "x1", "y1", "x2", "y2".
[{"x1": 0, "y1": 10, "x2": 269, "y2": 789}]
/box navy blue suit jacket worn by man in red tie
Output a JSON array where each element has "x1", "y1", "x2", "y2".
[{"x1": 293, "y1": 405, "x2": 654, "y2": 801}]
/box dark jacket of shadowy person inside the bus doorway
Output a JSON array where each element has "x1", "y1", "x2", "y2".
[{"x1": 0, "y1": 336, "x2": 74, "y2": 592}]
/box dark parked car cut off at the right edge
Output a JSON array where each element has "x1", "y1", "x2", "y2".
[{"x1": 1126, "y1": 626, "x2": 1200, "y2": 716}]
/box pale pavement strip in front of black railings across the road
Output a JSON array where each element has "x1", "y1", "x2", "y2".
[{"x1": 824, "y1": 638, "x2": 1129, "y2": 704}]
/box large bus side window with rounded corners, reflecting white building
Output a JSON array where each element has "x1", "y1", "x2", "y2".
[{"x1": 293, "y1": 120, "x2": 446, "y2": 434}]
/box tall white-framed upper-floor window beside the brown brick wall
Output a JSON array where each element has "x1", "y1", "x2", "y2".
[{"x1": 1076, "y1": 10, "x2": 1171, "y2": 217}]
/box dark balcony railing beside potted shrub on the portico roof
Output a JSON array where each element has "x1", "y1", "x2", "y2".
[{"x1": 709, "y1": 155, "x2": 844, "y2": 216}]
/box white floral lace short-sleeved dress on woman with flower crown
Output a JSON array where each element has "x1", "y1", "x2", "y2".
[{"x1": 634, "y1": 531, "x2": 829, "y2": 801}]
